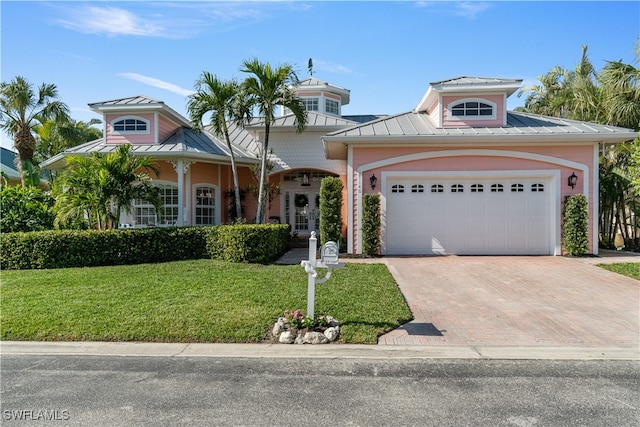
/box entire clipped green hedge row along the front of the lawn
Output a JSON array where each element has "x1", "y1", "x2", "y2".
[{"x1": 0, "y1": 225, "x2": 289, "y2": 270}]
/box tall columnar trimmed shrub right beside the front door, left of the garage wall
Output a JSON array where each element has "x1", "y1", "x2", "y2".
[{"x1": 320, "y1": 177, "x2": 343, "y2": 245}]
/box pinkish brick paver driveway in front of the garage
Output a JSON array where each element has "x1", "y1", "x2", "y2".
[{"x1": 379, "y1": 256, "x2": 640, "y2": 348}]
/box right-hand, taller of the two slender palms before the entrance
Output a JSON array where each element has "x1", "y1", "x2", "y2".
[{"x1": 240, "y1": 58, "x2": 307, "y2": 224}]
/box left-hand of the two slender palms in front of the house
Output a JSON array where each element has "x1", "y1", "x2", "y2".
[{"x1": 187, "y1": 71, "x2": 242, "y2": 219}]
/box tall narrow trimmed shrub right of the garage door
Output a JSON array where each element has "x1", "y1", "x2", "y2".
[{"x1": 562, "y1": 194, "x2": 589, "y2": 256}]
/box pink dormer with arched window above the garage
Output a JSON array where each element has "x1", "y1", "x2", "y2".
[{"x1": 415, "y1": 77, "x2": 522, "y2": 128}]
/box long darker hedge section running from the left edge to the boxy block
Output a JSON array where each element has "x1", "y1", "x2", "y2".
[{"x1": 0, "y1": 227, "x2": 210, "y2": 269}]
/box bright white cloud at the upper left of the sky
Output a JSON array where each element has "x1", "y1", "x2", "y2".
[{"x1": 58, "y1": 6, "x2": 167, "y2": 37}]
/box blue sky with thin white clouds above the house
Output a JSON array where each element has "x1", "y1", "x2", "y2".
[{"x1": 0, "y1": 0, "x2": 640, "y2": 148}]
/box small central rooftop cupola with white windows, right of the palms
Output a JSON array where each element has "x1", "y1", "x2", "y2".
[{"x1": 283, "y1": 77, "x2": 350, "y2": 117}]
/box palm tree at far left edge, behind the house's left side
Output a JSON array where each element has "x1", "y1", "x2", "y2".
[{"x1": 0, "y1": 76, "x2": 69, "y2": 185}]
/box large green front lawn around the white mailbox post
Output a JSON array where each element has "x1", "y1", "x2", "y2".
[{"x1": 0, "y1": 260, "x2": 412, "y2": 344}]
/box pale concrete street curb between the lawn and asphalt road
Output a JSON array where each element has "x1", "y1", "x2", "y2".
[{"x1": 0, "y1": 341, "x2": 640, "y2": 361}]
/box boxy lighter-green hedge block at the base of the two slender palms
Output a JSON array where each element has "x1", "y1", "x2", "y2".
[{"x1": 207, "y1": 224, "x2": 290, "y2": 264}]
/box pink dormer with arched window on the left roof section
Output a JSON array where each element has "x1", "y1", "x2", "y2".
[{"x1": 89, "y1": 96, "x2": 191, "y2": 144}]
